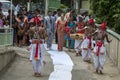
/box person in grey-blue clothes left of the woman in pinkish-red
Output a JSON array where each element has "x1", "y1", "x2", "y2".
[{"x1": 44, "y1": 11, "x2": 55, "y2": 50}]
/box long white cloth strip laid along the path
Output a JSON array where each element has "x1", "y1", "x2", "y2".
[{"x1": 45, "y1": 44, "x2": 73, "y2": 80}]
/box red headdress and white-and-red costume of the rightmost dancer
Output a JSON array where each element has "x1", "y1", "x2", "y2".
[{"x1": 93, "y1": 22, "x2": 106, "y2": 71}]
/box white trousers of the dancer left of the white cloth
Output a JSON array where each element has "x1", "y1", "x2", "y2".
[{"x1": 30, "y1": 44, "x2": 45, "y2": 73}]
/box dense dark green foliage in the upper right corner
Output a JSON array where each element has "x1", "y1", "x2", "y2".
[{"x1": 90, "y1": 0, "x2": 120, "y2": 33}]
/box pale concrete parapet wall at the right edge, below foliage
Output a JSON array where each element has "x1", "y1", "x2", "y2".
[{"x1": 106, "y1": 30, "x2": 120, "y2": 71}]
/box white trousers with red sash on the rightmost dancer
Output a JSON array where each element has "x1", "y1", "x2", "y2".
[{"x1": 93, "y1": 41, "x2": 106, "y2": 70}]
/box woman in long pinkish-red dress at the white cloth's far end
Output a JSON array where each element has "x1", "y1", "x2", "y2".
[{"x1": 56, "y1": 13, "x2": 66, "y2": 51}]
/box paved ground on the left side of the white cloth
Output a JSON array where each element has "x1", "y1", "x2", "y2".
[{"x1": 0, "y1": 48, "x2": 53, "y2": 80}]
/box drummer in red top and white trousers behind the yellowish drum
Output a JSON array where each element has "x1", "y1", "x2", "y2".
[{"x1": 74, "y1": 16, "x2": 85, "y2": 56}]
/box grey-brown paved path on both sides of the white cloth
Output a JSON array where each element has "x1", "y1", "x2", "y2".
[{"x1": 0, "y1": 44, "x2": 120, "y2": 80}]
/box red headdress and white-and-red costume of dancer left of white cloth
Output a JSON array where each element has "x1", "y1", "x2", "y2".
[{"x1": 30, "y1": 17, "x2": 45, "y2": 74}]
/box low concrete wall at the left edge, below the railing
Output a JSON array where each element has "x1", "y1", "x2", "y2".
[{"x1": 0, "y1": 47, "x2": 15, "y2": 74}]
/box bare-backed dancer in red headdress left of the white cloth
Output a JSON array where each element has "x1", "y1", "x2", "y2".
[{"x1": 27, "y1": 16, "x2": 45, "y2": 77}]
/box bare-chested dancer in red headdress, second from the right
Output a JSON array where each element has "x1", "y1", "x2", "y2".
[{"x1": 81, "y1": 19, "x2": 95, "y2": 63}]
